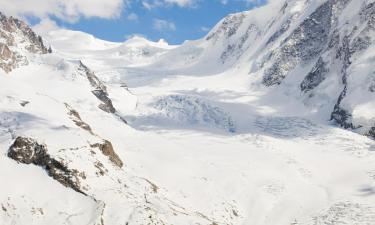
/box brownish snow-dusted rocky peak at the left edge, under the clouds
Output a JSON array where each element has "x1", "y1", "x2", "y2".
[{"x1": 0, "y1": 13, "x2": 49, "y2": 73}]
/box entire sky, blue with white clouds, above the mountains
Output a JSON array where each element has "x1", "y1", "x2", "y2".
[{"x1": 0, "y1": 0, "x2": 266, "y2": 44}]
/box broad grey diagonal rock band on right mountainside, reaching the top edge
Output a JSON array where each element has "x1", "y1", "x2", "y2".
[{"x1": 263, "y1": 0, "x2": 349, "y2": 86}]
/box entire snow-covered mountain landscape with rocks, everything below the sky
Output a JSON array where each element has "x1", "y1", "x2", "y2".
[{"x1": 0, "y1": 0, "x2": 375, "y2": 225}]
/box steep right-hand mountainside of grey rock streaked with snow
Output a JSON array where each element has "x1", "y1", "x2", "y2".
[{"x1": 197, "y1": 0, "x2": 375, "y2": 137}]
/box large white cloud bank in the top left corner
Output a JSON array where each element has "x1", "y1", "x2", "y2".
[{"x1": 0, "y1": 0, "x2": 128, "y2": 22}]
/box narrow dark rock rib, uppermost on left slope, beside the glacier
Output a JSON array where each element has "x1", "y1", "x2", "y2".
[{"x1": 78, "y1": 62, "x2": 116, "y2": 113}]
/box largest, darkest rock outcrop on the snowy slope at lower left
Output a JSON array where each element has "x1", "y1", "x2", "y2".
[{"x1": 8, "y1": 137, "x2": 85, "y2": 194}]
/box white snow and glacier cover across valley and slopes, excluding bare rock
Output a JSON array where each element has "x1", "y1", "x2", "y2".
[{"x1": 0, "y1": 0, "x2": 375, "y2": 225}]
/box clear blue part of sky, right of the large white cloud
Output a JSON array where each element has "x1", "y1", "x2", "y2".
[{"x1": 50, "y1": 0, "x2": 268, "y2": 44}]
